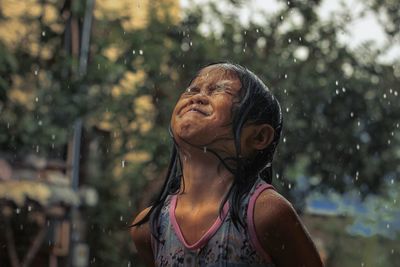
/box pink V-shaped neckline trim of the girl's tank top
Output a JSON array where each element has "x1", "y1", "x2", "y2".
[{"x1": 169, "y1": 195, "x2": 229, "y2": 250}]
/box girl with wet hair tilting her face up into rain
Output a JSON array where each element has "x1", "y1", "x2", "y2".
[{"x1": 131, "y1": 63, "x2": 322, "y2": 267}]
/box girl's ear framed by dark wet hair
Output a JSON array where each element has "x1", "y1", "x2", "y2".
[{"x1": 242, "y1": 123, "x2": 275, "y2": 154}]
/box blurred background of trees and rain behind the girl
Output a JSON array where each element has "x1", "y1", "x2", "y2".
[{"x1": 0, "y1": 0, "x2": 400, "y2": 267}]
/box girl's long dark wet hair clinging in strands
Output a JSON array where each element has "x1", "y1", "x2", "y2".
[{"x1": 132, "y1": 62, "x2": 282, "y2": 234}]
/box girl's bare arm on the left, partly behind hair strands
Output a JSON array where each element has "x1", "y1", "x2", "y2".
[{"x1": 130, "y1": 208, "x2": 155, "y2": 267}]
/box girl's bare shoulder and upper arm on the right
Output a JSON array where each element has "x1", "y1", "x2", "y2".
[{"x1": 254, "y1": 190, "x2": 323, "y2": 267}]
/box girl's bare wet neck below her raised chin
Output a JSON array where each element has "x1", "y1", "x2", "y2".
[{"x1": 180, "y1": 150, "x2": 233, "y2": 206}]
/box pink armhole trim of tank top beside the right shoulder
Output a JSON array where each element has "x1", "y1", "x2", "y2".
[{"x1": 247, "y1": 184, "x2": 275, "y2": 262}]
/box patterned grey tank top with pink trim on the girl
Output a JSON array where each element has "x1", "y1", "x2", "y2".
[{"x1": 151, "y1": 179, "x2": 275, "y2": 267}]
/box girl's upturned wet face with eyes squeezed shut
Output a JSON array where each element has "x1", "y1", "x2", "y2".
[{"x1": 171, "y1": 66, "x2": 241, "y2": 149}]
